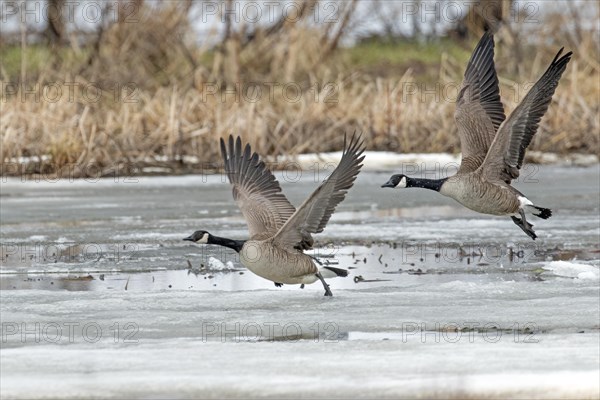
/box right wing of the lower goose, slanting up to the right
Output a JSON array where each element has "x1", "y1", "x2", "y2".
[{"x1": 273, "y1": 135, "x2": 365, "y2": 249}]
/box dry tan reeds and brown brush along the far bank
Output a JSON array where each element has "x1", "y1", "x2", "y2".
[{"x1": 0, "y1": 2, "x2": 600, "y2": 175}]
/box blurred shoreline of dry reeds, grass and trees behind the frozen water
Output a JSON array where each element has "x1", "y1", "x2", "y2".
[{"x1": 0, "y1": 0, "x2": 600, "y2": 176}]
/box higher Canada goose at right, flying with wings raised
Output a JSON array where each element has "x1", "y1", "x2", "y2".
[{"x1": 382, "y1": 33, "x2": 572, "y2": 240}]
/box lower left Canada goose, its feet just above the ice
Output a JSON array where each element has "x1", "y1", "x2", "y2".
[{"x1": 184, "y1": 136, "x2": 364, "y2": 296}]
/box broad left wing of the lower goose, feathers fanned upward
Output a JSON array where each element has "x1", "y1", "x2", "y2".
[{"x1": 221, "y1": 135, "x2": 296, "y2": 239}]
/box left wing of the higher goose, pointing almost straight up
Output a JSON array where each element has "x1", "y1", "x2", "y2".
[{"x1": 454, "y1": 31, "x2": 506, "y2": 172}]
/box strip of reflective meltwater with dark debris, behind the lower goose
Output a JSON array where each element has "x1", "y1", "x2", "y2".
[{"x1": 0, "y1": 242, "x2": 599, "y2": 291}]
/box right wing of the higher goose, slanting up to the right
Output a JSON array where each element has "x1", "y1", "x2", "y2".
[{"x1": 481, "y1": 49, "x2": 573, "y2": 182}]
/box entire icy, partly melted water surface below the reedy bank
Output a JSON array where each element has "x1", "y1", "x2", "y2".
[{"x1": 0, "y1": 166, "x2": 600, "y2": 398}]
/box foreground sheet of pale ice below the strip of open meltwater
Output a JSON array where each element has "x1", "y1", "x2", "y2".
[{"x1": 0, "y1": 288, "x2": 600, "y2": 399}]
